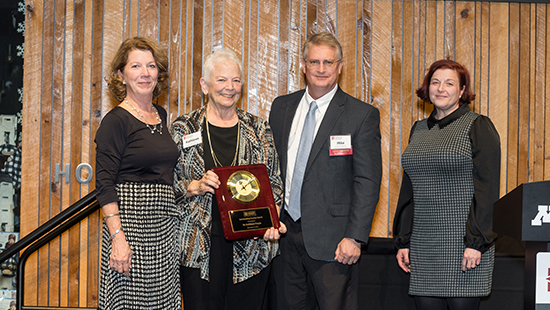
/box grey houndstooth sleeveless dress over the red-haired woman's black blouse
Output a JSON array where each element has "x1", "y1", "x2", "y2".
[{"x1": 402, "y1": 112, "x2": 494, "y2": 297}]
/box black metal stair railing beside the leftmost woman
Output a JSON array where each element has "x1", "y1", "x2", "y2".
[{"x1": 0, "y1": 190, "x2": 99, "y2": 310}]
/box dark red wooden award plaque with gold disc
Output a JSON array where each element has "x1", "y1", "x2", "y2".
[{"x1": 212, "y1": 164, "x2": 279, "y2": 240}]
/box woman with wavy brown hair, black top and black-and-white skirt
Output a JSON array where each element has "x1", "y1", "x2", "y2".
[{"x1": 95, "y1": 37, "x2": 181, "y2": 310}]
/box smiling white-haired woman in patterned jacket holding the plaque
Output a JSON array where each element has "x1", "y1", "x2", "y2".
[{"x1": 170, "y1": 48, "x2": 286, "y2": 309}]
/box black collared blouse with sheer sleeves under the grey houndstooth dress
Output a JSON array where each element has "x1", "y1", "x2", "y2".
[{"x1": 393, "y1": 104, "x2": 500, "y2": 252}]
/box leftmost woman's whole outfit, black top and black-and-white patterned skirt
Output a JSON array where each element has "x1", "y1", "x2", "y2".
[{"x1": 96, "y1": 106, "x2": 181, "y2": 310}]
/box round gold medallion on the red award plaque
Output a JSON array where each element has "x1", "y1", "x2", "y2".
[{"x1": 227, "y1": 170, "x2": 260, "y2": 203}]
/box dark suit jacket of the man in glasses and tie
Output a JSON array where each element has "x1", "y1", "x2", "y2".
[{"x1": 269, "y1": 88, "x2": 382, "y2": 260}]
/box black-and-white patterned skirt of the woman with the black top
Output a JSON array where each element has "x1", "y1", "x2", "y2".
[{"x1": 99, "y1": 183, "x2": 181, "y2": 310}]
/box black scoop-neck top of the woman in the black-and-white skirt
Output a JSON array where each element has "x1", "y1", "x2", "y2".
[{"x1": 95, "y1": 104, "x2": 179, "y2": 207}]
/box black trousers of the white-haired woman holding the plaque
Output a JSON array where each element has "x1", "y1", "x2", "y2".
[{"x1": 180, "y1": 235, "x2": 271, "y2": 310}]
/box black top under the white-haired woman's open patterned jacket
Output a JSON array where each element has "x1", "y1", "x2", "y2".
[{"x1": 202, "y1": 123, "x2": 239, "y2": 235}]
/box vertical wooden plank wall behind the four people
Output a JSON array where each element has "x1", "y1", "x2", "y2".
[{"x1": 21, "y1": 0, "x2": 550, "y2": 307}]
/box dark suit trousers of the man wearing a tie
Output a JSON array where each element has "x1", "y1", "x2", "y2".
[{"x1": 273, "y1": 212, "x2": 359, "y2": 310}]
